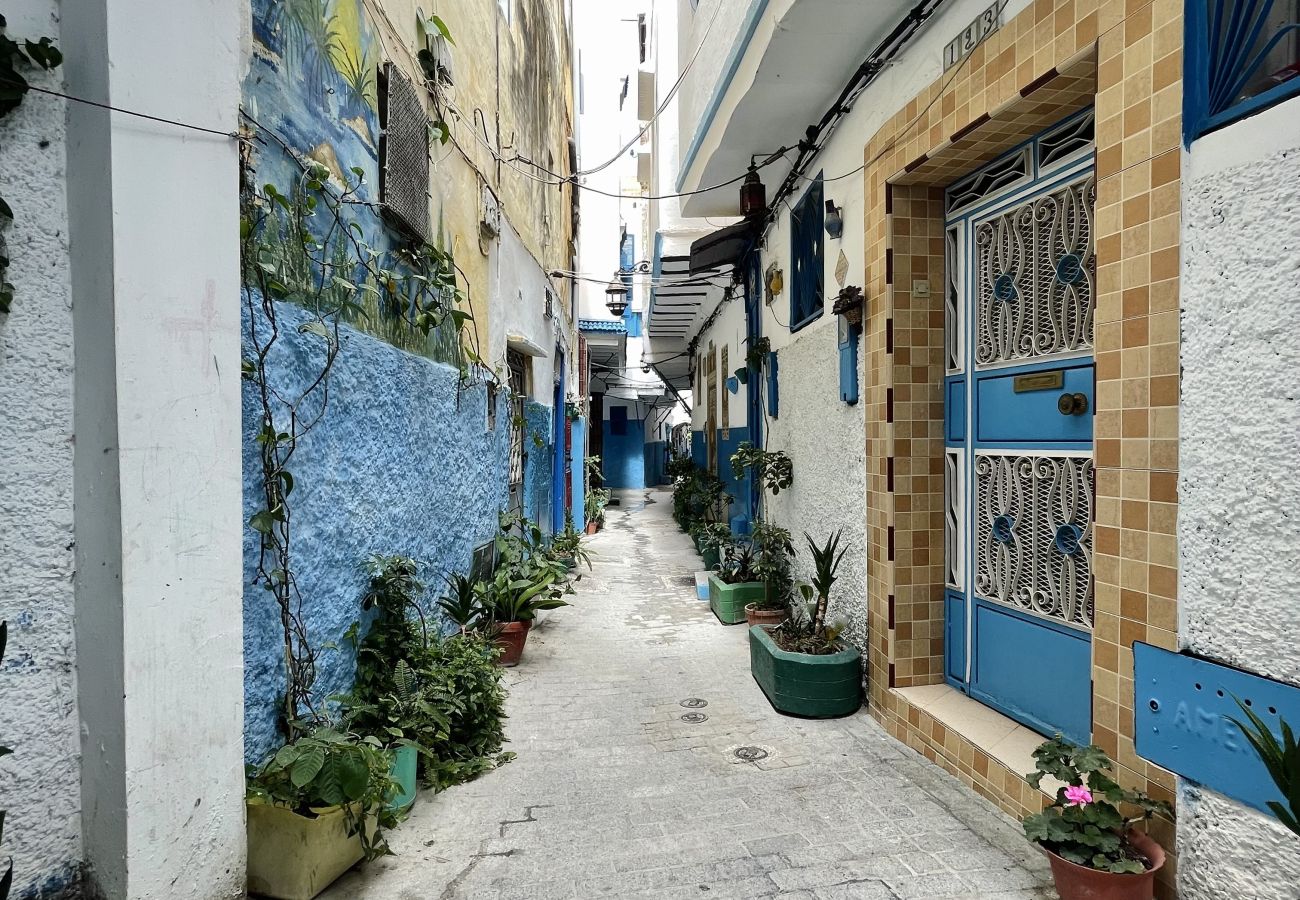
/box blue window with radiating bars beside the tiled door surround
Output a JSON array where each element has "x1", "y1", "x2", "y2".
[{"x1": 1183, "y1": 0, "x2": 1300, "y2": 144}]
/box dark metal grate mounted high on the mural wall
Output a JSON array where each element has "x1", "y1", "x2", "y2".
[{"x1": 380, "y1": 62, "x2": 430, "y2": 243}]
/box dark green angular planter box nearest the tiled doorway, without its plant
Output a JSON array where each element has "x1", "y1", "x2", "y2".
[{"x1": 741, "y1": 626, "x2": 862, "y2": 719}]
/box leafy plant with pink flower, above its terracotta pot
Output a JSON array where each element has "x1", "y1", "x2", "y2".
[{"x1": 1023, "y1": 735, "x2": 1174, "y2": 874}]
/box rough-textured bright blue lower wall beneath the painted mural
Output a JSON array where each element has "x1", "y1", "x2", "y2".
[{"x1": 243, "y1": 303, "x2": 509, "y2": 762}]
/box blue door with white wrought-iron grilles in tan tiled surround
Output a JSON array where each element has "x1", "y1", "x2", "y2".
[{"x1": 945, "y1": 112, "x2": 1096, "y2": 741}]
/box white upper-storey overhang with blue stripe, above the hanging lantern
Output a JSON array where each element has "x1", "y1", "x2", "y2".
[{"x1": 677, "y1": 0, "x2": 915, "y2": 217}]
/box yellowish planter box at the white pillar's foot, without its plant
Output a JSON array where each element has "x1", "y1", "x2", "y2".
[{"x1": 248, "y1": 802, "x2": 374, "y2": 900}]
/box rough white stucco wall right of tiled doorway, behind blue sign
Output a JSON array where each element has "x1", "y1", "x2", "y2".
[{"x1": 1178, "y1": 91, "x2": 1300, "y2": 900}]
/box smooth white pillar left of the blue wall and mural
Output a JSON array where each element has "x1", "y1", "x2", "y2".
[{"x1": 62, "y1": 0, "x2": 247, "y2": 900}]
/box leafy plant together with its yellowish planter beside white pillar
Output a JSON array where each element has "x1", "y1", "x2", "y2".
[{"x1": 247, "y1": 726, "x2": 397, "y2": 900}]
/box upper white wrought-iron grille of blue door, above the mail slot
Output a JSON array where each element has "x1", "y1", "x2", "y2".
[{"x1": 975, "y1": 174, "x2": 1097, "y2": 367}]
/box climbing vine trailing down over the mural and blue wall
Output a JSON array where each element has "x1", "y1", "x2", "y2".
[{"x1": 241, "y1": 161, "x2": 469, "y2": 741}]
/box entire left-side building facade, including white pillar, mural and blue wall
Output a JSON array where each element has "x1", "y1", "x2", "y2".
[{"x1": 0, "y1": 0, "x2": 584, "y2": 899}]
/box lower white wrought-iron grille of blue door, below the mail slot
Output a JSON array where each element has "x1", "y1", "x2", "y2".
[{"x1": 975, "y1": 453, "x2": 1095, "y2": 628}]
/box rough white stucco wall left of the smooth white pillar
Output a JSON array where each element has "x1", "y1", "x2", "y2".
[{"x1": 0, "y1": 0, "x2": 81, "y2": 896}]
